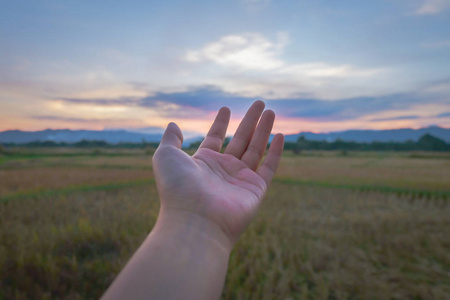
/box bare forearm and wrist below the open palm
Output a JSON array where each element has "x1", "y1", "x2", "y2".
[{"x1": 103, "y1": 211, "x2": 232, "y2": 300}]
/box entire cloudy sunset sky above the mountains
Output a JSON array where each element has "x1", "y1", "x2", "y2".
[{"x1": 0, "y1": 0, "x2": 450, "y2": 134}]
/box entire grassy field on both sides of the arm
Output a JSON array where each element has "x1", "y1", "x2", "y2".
[{"x1": 0, "y1": 149, "x2": 450, "y2": 299}]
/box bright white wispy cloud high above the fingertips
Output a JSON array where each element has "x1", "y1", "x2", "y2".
[{"x1": 183, "y1": 33, "x2": 386, "y2": 100}]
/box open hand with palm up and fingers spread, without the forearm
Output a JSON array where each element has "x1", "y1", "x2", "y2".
[{"x1": 153, "y1": 101, "x2": 284, "y2": 247}]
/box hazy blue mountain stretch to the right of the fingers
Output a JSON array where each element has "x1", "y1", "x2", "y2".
[{"x1": 285, "y1": 126, "x2": 450, "y2": 143}]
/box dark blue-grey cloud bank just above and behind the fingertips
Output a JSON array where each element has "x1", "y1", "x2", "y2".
[{"x1": 141, "y1": 86, "x2": 436, "y2": 121}]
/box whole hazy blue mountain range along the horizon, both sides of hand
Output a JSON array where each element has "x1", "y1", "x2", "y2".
[{"x1": 0, "y1": 126, "x2": 450, "y2": 146}]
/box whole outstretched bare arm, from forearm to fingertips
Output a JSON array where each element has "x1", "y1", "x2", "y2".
[{"x1": 103, "y1": 101, "x2": 284, "y2": 299}]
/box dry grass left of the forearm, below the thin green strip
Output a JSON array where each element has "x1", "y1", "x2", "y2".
[{"x1": 0, "y1": 186, "x2": 158, "y2": 299}]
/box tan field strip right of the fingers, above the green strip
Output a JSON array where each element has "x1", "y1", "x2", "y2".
[{"x1": 278, "y1": 154, "x2": 450, "y2": 191}]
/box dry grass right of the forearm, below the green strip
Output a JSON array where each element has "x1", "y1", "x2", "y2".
[{"x1": 223, "y1": 184, "x2": 450, "y2": 299}]
